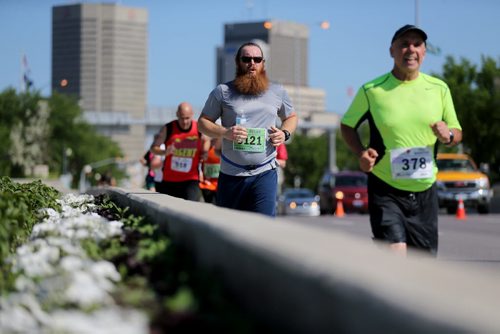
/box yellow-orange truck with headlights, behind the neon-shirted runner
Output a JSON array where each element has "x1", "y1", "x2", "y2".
[{"x1": 436, "y1": 153, "x2": 493, "y2": 214}]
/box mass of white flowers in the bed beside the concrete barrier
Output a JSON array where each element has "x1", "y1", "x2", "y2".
[{"x1": 0, "y1": 194, "x2": 148, "y2": 334}]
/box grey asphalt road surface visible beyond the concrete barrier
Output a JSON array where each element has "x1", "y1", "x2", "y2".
[{"x1": 283, "y1": 212, "x2": 500, "y2": 274}]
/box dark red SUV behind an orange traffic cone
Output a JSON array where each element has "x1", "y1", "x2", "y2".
[{"x1": 318, "y1": 171, "x2": 368, "y2": 214}]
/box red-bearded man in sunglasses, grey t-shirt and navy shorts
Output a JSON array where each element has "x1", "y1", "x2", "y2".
[{"x1": 198, "y1": 43, "x2": 297, "y2": 216}]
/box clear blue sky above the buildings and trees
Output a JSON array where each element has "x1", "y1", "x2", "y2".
[{"x1": 0, "y1": 0, "x2": 500, "y2": 113}]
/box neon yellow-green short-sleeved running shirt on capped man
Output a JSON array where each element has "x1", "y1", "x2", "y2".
[{"x1": 341, "y1": 73, "x2": 462, "y2": 192}]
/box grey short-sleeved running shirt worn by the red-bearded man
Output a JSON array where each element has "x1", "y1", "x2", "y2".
[{"x1": 201, "y1": 81, "x2": 293, "y2": 176}]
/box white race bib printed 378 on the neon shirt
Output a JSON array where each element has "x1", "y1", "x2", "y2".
[{"x1": 391, "y1": 147, "x2": 433, "y2": 179}]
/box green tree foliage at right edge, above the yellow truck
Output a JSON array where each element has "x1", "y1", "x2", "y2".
[{"x1": 441, "y1": 56, "x2": 500, "y2": 178}]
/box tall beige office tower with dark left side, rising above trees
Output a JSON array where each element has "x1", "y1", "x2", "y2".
[{"x1": 52, "y1": 3, "x2": 148, "y2": 159}]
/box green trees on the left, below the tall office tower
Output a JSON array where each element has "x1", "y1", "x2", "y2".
[{"x1": 0, "y1": 88, "x2": 123, "y2": 185}]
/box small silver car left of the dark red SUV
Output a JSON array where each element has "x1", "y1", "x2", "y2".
[{"x1": 277, "y1": 188, "x2": 320, "y2": 216}]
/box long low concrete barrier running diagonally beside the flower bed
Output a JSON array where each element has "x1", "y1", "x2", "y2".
[{"x1": 90, "y1": 188, "x2": 500, "y2": 333}]
